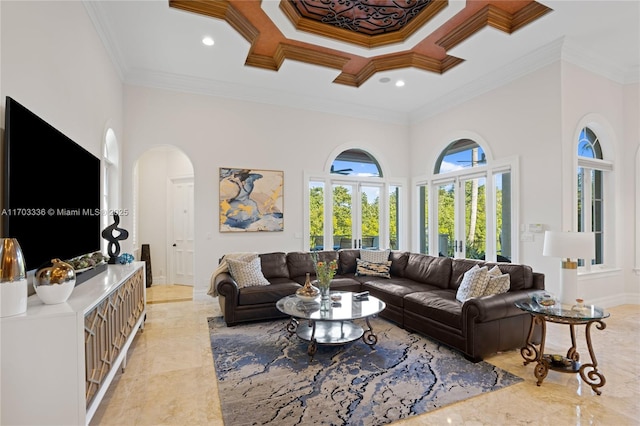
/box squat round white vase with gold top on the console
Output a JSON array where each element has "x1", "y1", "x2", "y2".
[{"x1": 33, "y1": 259, "x2": 76, "y2": 305}]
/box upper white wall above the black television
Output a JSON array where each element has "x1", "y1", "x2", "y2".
[{"x1": 0, "y1": 1, "x2": 123, "y2": 157}]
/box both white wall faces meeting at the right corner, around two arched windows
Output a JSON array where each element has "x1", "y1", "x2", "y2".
[{"x1": 410, "y1": 62, "x2": 640, "y2": 306}]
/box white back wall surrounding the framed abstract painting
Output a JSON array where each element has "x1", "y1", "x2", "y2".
[{"x1": 123, "y1": 86, "x2": 408, "y2": 293}]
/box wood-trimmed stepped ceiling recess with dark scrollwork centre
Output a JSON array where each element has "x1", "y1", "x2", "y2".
[{"x1": 169, "y1": 0, "x2": 552, "y2": 87}]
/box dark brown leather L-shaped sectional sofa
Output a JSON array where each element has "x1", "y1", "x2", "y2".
[{"x1": 212, "y1": 249, "x2": 544, "y2": 361}]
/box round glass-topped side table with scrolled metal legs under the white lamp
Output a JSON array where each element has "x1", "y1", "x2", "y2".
[{"x1": 516, "y1": 299, "x2": 609, "y2": 395}]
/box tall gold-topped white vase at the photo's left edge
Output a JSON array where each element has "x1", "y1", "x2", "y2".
[{"x1": 0, "y1": 238, "x2": 27, "y2": 317}]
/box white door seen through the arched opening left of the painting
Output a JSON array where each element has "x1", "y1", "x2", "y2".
[{"x1": 169, "y1": 178, "x2": 194, "y2": 286}]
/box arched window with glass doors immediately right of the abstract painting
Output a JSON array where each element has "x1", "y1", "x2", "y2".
[{"x1": 307, "y1": 148, "x2": 402, "y2": 250}]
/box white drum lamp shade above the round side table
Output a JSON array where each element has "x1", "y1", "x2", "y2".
[{"x1": 542, "y1": 231, "x2": 596, "y2": 260}]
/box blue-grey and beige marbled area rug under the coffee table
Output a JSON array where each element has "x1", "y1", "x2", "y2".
[{"x1": 208, "y1": 317, "x2": 523, "y2": 426}]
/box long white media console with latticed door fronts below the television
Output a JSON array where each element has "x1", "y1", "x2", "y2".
[{"x1": 0, "y1": 262, "x2": 146, "y2": 425}]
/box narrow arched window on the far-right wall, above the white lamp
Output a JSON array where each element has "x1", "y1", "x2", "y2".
[{"x1": 577, "y1": 127, "x2": 612, "y2": 266}]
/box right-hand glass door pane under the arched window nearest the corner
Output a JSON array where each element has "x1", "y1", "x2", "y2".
[{"x1": 460, "y1": 177, "x2": 487, "y2": 259}]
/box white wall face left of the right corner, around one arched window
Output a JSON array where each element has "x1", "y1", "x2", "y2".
[{"x1": 410, "y1": 64, "x2": 561, "y2": 272}]
